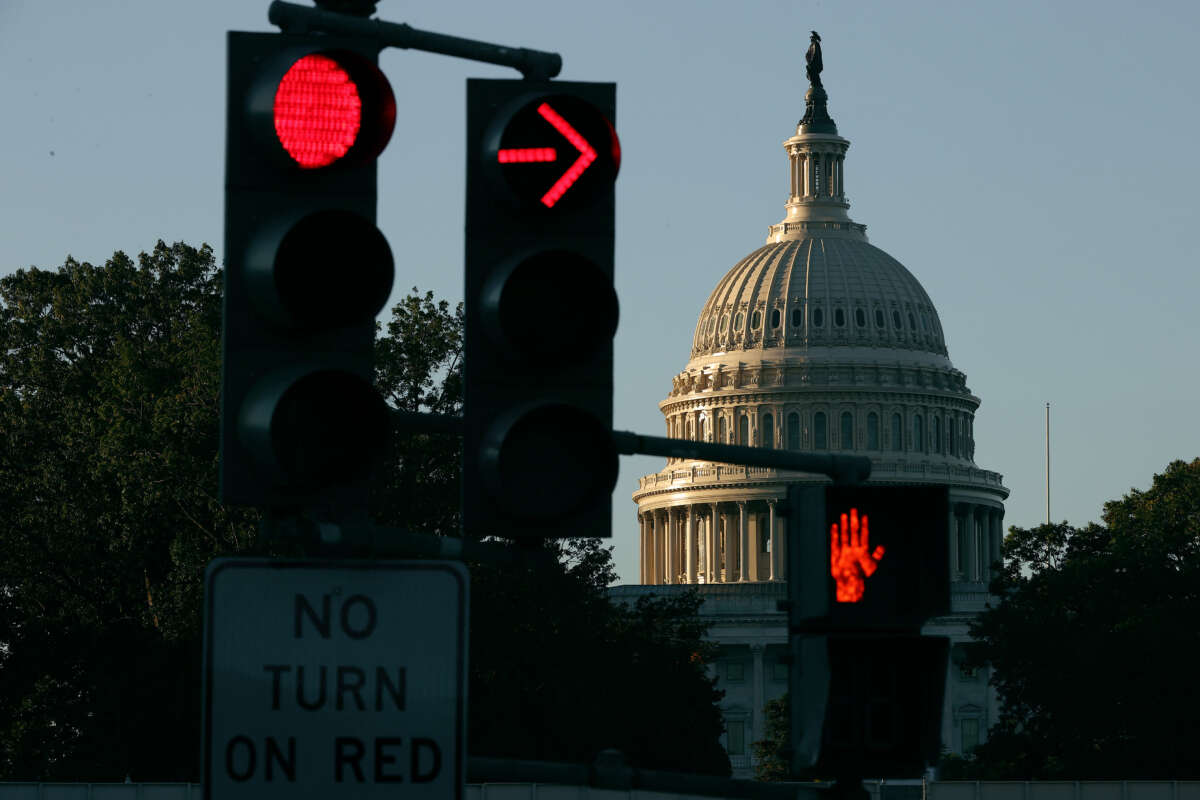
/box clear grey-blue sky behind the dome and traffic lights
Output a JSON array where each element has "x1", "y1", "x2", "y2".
[{"x1": 0, "y1": 0, "x2": 1200, "y2": 583}]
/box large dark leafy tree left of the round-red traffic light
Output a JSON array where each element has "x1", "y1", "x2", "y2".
[{"x1": 0, "y1": 242, "x2": 253, "y2": 780}]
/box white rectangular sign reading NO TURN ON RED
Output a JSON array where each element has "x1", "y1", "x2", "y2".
[{"x1": 202, "y1": 558, "x2": 468, "y2": 800}]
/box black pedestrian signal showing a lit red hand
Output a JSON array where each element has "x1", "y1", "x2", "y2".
[{"x1": 787, "y1": 486, "x2": 950, "y2": 777}]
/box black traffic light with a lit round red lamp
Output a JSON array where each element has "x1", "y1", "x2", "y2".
[{"x1": 221, "y1": 31, "x2": 396, "y2": 516}]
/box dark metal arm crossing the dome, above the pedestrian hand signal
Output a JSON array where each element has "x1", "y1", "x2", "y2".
[{"x1": 612, "y1": 431, "x2": 871, "y2": 485}]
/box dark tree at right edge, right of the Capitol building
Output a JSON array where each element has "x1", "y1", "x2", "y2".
[{"x1": 960, "y1": 459, "x2": 1200, "y2": 778}]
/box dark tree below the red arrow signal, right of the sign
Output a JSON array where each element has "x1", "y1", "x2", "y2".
[{"x1": 470, "y1": 540, "x2": 730, "y2": 775}]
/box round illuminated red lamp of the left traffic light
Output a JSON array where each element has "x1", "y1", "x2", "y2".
[{"x1": 275, "y1": 54, "x2": 362, "y2": 169}]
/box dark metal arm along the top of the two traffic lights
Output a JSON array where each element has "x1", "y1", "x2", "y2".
[{"x1": 266, "y1": 0, "x2": 563, "y2": 80}]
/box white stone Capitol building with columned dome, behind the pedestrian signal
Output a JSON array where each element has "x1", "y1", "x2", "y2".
[{"x1": 613, "y1": 73, "x2": 1008, "y2": 777}]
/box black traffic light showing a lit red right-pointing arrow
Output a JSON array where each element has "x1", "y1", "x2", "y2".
[{"x1": 462, "y1": 80, "x2": 620, "y2": 539}]
